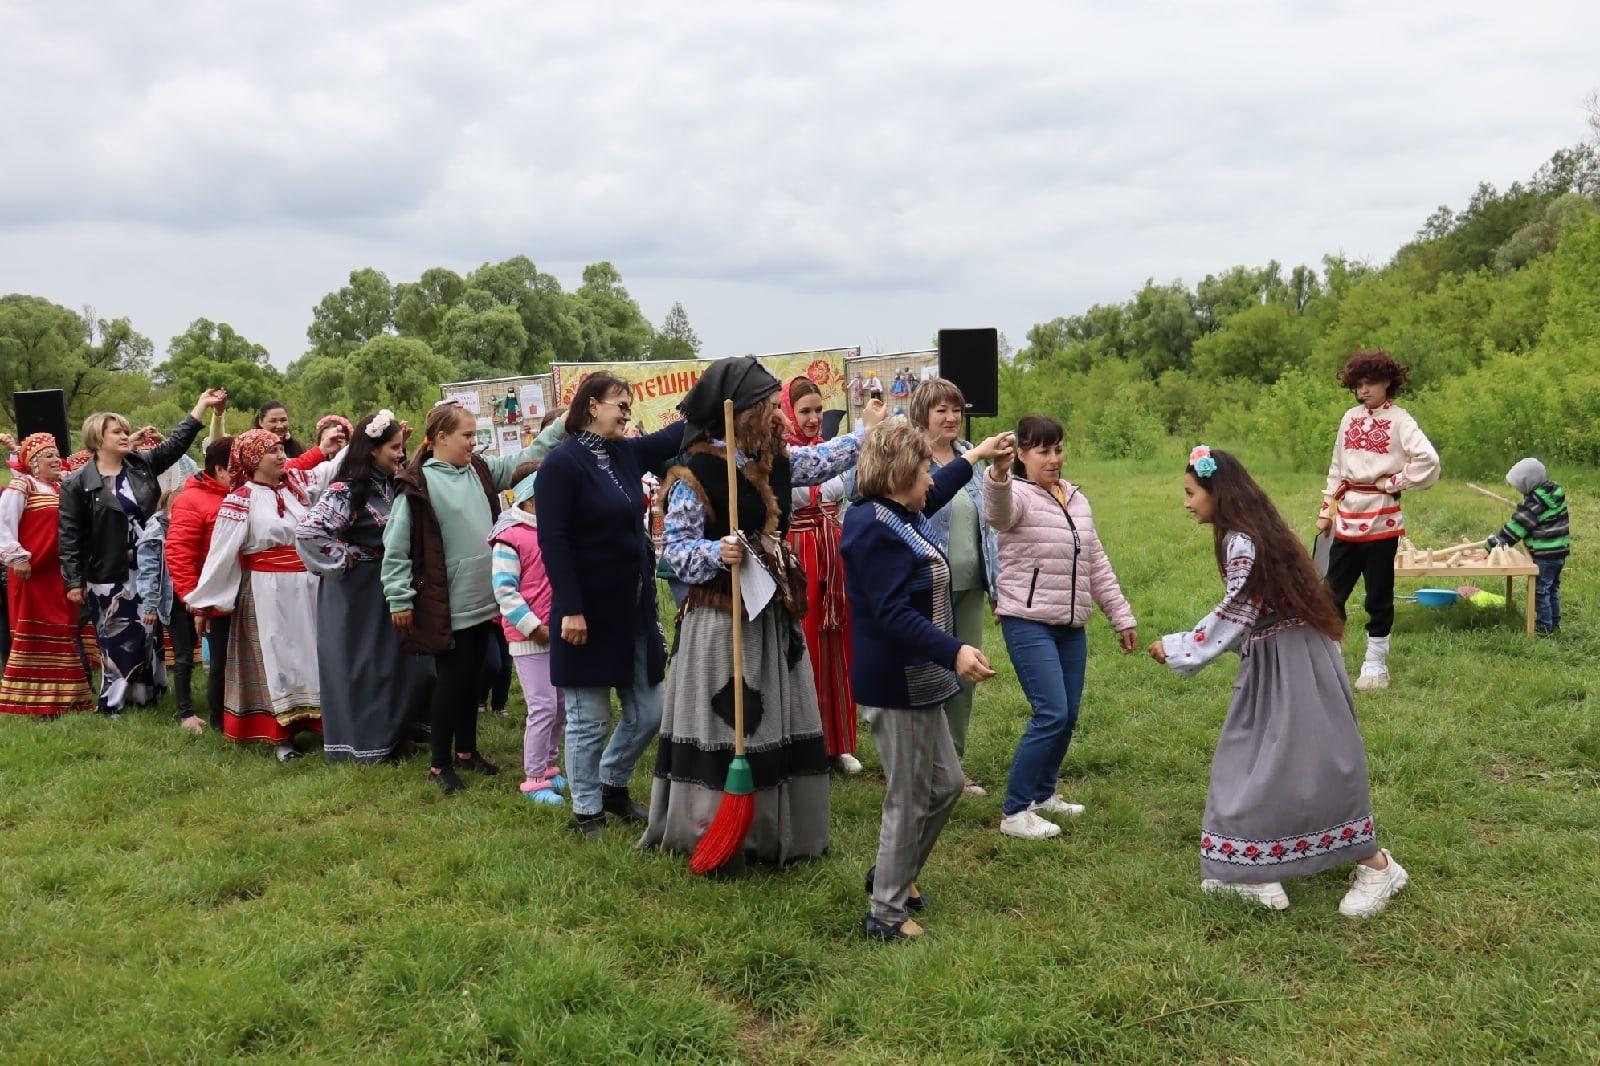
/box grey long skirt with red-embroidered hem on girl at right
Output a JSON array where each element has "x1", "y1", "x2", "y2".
[{"x1": 1200, "y1": 623, "x2": 1378, "y2": 884}]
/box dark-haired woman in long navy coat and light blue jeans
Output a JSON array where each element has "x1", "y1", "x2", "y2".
[{"x1": 534, "y1": 373, "x2": 683, "y2": 839}]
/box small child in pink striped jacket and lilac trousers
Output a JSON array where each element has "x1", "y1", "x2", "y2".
[{"x1": 490, "y1": 463, "x2": 566, "y2": 807}]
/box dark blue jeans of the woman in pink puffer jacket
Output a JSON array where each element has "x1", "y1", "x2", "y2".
[{"x1": 1000, "y1": 618, "x2": 1088, "y2": 815}]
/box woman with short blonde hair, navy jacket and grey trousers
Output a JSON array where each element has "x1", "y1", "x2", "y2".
[{"x1": 842, "y1": 418, "x2": 1011, "y2": 940}]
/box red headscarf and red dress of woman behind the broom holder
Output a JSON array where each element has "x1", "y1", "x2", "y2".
[{"x1": 781, "y1": 372, "x2": 856, "y2": 759}]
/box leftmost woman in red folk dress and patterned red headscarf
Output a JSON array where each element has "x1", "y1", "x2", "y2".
[{"x1": 0, "y1": 434, "x2": 94, "y2": 717}]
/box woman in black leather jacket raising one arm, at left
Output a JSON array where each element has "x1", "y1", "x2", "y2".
[{"x1": 61, "y1": 389, "x2": 227, "y2": 714}]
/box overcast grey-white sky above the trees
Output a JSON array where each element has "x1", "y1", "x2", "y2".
[{"x1": 0, "y1": 0, "x2": 1600, "y2": 365}]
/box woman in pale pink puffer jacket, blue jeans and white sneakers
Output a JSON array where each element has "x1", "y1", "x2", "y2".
[{"x1": 982, "y1": 415, "x2": 1139, "y2": 840}]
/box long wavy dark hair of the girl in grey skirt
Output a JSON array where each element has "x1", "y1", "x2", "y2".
[{"x1": 1187, "y1": 448, "x2": 1344, "y2": 640}]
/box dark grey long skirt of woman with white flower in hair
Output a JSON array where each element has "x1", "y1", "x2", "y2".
[{"x1": 317, "y1": 559, "x2": 434, "y2": 762}]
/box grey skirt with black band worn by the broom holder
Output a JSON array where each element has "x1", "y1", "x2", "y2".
[{"x1": 638, "y1": 602, "x2": 829, "y2": 863}]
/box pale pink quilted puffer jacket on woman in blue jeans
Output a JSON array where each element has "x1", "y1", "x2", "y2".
[{"x1": 982, "y1": 474, "x2": 1134, "y2": 632}]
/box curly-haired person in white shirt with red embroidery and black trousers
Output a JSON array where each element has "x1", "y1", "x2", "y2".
[{"x1": 1317, "y1": 351, "x2": 1438, "y2": 688}]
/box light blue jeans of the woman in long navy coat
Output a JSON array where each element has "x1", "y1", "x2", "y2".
[{"x1": 562, "y1": 635, "x2": 662, "y2": 815}]
